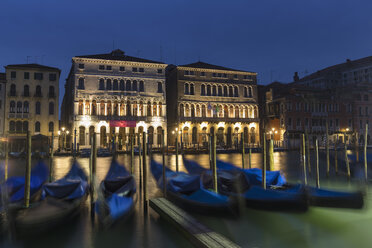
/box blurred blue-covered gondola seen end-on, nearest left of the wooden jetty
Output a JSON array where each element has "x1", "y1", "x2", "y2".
[{"x1": 95, "y1": 159, "x2": 137, "y2": 226}]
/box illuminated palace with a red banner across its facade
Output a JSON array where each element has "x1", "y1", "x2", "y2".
[{"x1": 61, "y1": 50, "x2": 167, "y2": 149}]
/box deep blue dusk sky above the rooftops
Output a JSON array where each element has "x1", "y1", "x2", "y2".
[{"x1": 0, "y1": 0, "x2": 372, "y2": 107}]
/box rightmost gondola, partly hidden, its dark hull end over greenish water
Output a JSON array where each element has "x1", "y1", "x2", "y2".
[{"x1": 212, "y1": 160, "x2": 364, "y2": 209}]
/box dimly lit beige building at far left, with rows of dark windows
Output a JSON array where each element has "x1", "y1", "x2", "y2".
[{"x1": 4, "y1": 64, "x2": 61, "y2": 151}]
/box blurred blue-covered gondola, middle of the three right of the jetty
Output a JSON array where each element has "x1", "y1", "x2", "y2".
[{"x1": 183, "y1": 158, "x2": 308, "y2": 212}]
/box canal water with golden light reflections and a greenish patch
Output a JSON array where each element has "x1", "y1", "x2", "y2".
[{"x1": 0, "y1": 151, "x2": 372, "y2": 248}]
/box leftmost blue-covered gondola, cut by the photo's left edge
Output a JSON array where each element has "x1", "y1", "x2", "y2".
[{"x1": 0, "y1": 161, "x2": 48, "y2": 211}]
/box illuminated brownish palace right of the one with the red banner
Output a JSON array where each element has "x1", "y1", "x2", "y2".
[{"x1": 167, "y1": 62, "x2": 259, "y2": 148}]
